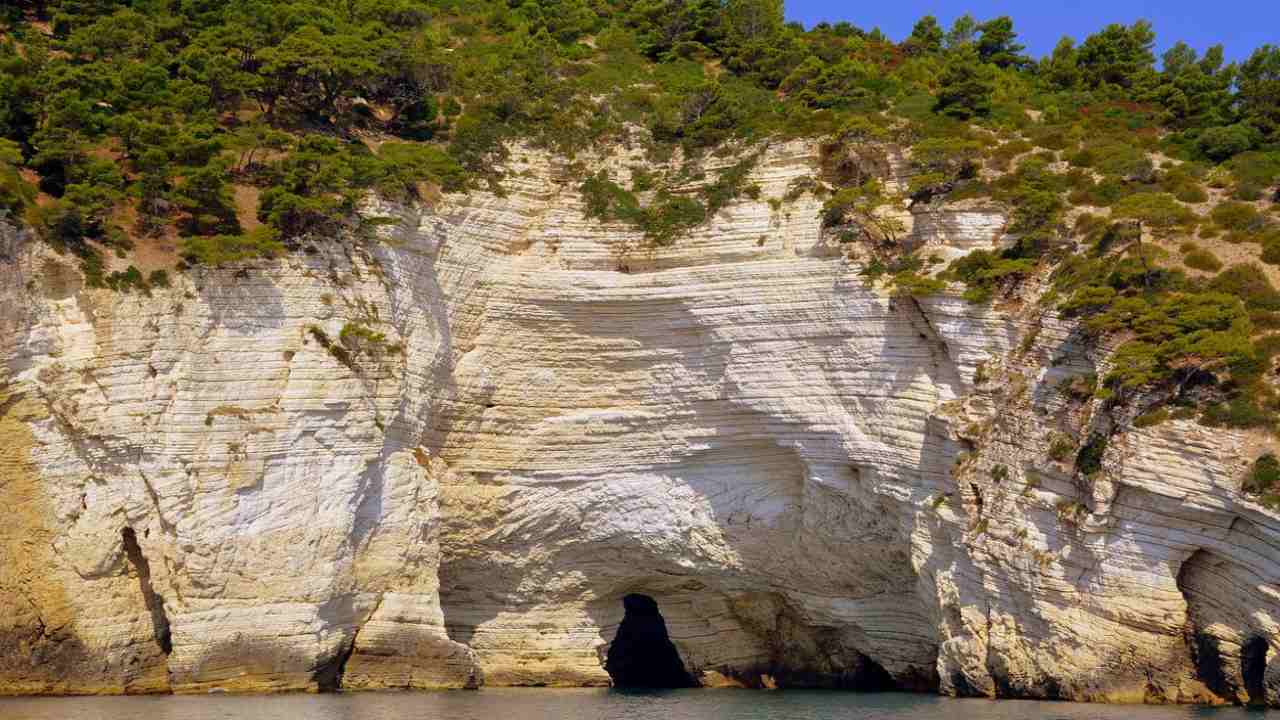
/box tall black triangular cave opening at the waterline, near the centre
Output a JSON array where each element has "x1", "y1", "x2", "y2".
[{"x1": 604, "y1": 594, "x2": 698, "y2": 688}]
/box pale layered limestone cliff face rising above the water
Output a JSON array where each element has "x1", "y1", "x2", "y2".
[{"x1": 0, "y1": 142, "x2": 1280, "y2": 705}]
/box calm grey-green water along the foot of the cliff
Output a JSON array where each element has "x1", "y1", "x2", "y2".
[{"x1": 0, "y1": 689, "x2": 1277, "y2": 720}]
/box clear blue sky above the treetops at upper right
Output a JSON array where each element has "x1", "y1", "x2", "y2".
[{"x1": 786, "y1": 0, "x2": 1280, "y2": 60}]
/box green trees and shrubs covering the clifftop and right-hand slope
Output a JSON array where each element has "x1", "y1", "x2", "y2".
[{"x1": 0, "y1": 0, "x2": 1280, "y2": 438}]
